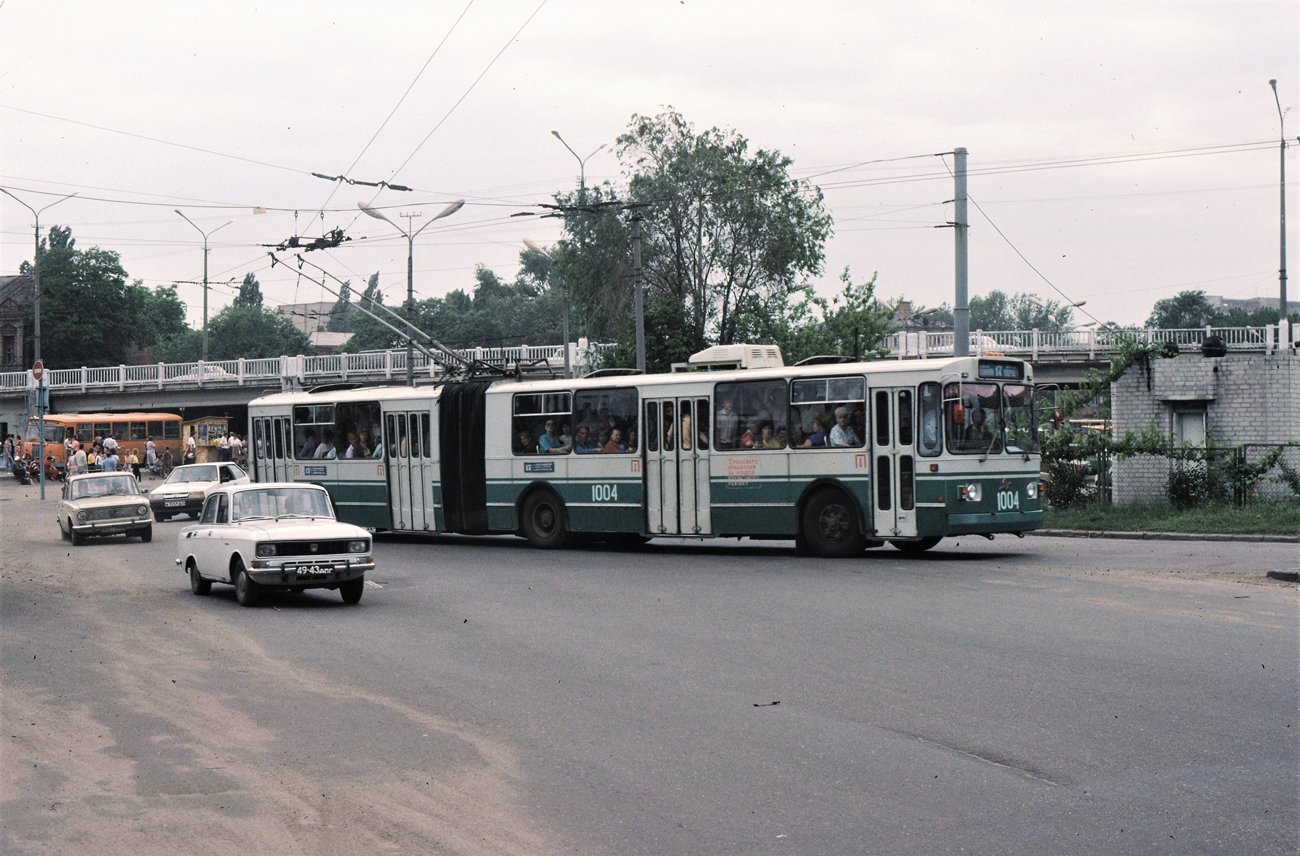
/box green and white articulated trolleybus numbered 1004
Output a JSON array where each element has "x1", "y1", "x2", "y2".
[{"x1": 248, "y1": 346, "x2": 1043, "y2": 557}]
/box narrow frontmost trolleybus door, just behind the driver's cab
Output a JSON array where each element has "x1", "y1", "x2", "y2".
[{"x1": 871, "y1": 388, "x2": 917, "y2": 537}]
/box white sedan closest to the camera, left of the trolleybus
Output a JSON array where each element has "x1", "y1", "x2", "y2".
[{"x1": 176, "y1": 483, "x2": 374, "y2": 606}]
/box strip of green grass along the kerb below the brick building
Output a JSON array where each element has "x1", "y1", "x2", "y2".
[{"x1": 1045, "y1": 500, "x2": 1300, "y2": 535}]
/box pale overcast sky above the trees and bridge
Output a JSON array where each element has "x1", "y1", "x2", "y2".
[{"x1": 0, "y1": 0, "x2": 1300, "y2": 340}]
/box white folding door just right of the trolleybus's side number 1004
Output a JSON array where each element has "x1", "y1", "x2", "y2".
[{"x1": 642, "y1": 398, "x2": 712, "y2": 536}]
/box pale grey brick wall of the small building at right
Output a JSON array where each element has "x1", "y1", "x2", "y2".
[{"x1": 1110, "y1": 351, "x2": 1300, "y2": 502}]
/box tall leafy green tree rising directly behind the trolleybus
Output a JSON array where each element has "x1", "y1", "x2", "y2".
[{"x1": 556, "y1": 109, "x2": 831, "y2": 368}]
